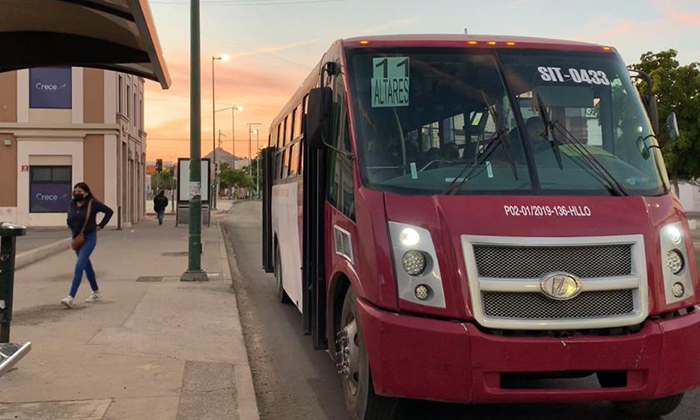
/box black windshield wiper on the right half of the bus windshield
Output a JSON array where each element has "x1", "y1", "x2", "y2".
[{"x1": 537, "y1": 94, "x2": 629, "y2": 196}]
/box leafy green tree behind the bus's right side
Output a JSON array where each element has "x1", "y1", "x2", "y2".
[{"x1": 632, "y1": 49, "x2": 700, "y2": 181}]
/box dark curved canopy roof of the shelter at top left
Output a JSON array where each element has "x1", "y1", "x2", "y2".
[{"x1": 0, "y1": 0, "x2": 170, "y2": 89}]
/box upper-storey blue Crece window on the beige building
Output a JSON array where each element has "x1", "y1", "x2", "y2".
[{"x1": 29, "y1": 68, "x2": 73, "y2": 109}]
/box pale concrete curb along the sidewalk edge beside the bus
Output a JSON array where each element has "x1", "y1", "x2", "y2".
[{"x1": 216, "y1": 220, "x2": 260, "y2": 420}]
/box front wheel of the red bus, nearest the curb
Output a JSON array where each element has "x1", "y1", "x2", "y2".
[{"x1": 336, "y1": 287, "x2": 398, "y2": 420}]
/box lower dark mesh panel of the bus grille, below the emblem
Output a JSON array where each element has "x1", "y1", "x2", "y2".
[{"x1": 482, "y1": 290, "x2": 634, "y2": 319}]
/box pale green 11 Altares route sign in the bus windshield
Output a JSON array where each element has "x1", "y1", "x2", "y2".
[{"x1": 372, "y1": 57, "x2": 410, "y2": 108}]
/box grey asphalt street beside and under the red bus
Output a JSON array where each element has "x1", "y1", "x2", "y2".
[{"x1": 224, "y1": 202, "x2": 700, "y2": 420}]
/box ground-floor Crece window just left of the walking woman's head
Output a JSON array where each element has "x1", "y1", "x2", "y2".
[{"x1": 29, "y1": 166, "x2": 73, "y2": 213}]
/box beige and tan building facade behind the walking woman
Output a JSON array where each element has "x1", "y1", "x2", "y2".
[{"x1": 0, "y1": 67, "x2": 146, "y2": 226}]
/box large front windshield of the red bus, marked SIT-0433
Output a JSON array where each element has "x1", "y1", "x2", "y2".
[{"x1": 347, "y1": 47, "x2": 669, "y2": 195}]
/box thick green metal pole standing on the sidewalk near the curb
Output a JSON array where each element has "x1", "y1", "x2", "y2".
[{"x1": 180, "y1": 0, "x2": 208, "y2": 281}]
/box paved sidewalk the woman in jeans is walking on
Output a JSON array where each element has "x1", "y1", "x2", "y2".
[{"x1": 0, "y1": 217, "x2": 258, "y2": 420}]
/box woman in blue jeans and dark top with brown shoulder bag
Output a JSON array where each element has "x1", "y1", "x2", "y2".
[{"x1": 61, "y1": 182, "x2": 114, "y2": 308}]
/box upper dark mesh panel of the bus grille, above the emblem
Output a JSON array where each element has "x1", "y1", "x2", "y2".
[{"x1": 474, "y1": 244, "x2": 632, "y2": 278}]
